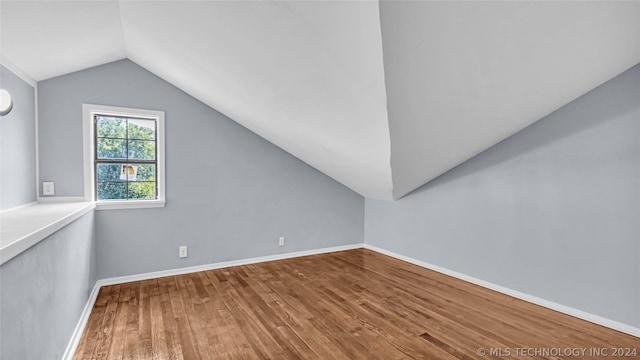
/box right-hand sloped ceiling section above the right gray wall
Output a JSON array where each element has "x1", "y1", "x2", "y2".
[{"x1": 380, "y1": 1, "x2": 640, "y2": 198}]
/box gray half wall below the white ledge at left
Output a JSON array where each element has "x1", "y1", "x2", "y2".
[{"x1": 0, "y1": 211, "x2": 96, "y2": 360}]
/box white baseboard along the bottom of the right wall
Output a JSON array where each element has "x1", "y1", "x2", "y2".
[{"x1": 364, "y1": 244, "x2": 640, "y2": 337}]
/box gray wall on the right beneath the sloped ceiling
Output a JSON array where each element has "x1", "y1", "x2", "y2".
[{"x1": 365, "y1": 65, "x2": 640, "y2": 327}]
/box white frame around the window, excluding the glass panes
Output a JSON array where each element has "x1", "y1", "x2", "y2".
[{"x1": 82, "y1": 104, "x2": 166, "y2": 210}]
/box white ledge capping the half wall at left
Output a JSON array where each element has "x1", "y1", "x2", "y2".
[{"x1": 0, "y1": 202, "x2": 96, "y2": 265}]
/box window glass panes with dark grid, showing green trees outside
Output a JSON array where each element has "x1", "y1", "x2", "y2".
[{"x1": 94, "y1": 115, "x2": 158, "y2": 200}]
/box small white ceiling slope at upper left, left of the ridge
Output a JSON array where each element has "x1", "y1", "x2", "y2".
[{"x1": 0, "y1": 0, "x2": 127, "y2": 81}]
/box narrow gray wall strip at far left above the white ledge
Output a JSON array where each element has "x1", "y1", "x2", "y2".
[{"x1": 0, "y1": 65, "x2": 36, "y2": 209}]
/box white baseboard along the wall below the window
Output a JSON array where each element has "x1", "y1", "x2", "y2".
[{"x1": 98, "y1": 244, "x2": 364, "y2": 286}]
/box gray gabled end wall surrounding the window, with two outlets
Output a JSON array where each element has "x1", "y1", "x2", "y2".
[{"x1": 38, "y1": 60, "x2": 364, "y2": 278}]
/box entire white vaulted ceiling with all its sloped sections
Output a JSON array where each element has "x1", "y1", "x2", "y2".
[{"x1": 0, "y1": 0, "x2": 640, "y2": 199}]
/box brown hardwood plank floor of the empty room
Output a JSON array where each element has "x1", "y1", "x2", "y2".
[{"x1": 74, "y1": 249, "x2": 640, "y2": 360}]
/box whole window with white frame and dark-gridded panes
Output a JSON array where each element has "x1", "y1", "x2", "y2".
[{"x1": 83, "y1": 104, "x2": 165, "y2": 209}]
